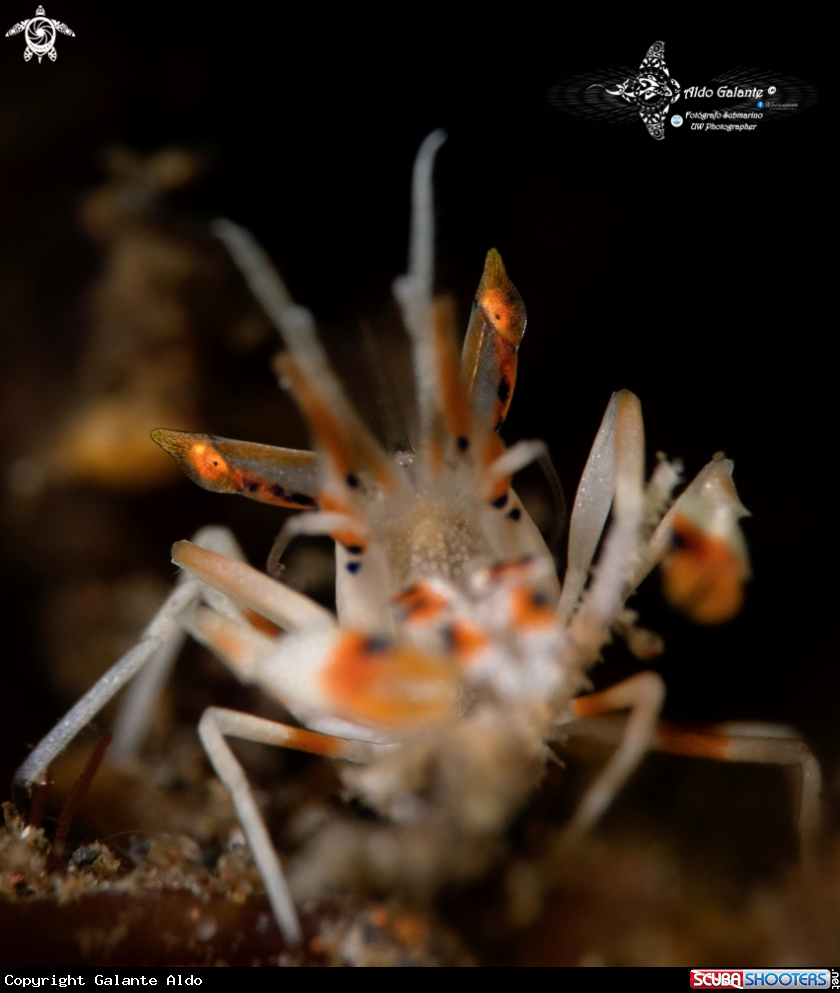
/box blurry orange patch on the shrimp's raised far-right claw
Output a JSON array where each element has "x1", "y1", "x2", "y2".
[{"x1": 662, "y1": 514, "x2": 746, "y2": 624}]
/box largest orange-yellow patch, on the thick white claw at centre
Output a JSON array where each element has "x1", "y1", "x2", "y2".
[{"x1": 321, "y1": 631, "x2": 457, "y2": 728}]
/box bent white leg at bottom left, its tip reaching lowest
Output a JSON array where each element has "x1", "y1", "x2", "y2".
[{"x1": 198, "y1": 707, "x2": 378, "y2": 945}]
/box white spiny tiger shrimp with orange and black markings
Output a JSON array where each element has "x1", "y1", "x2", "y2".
[{"x1": 16, "y1": 131, "x2": 819, "y2": 943}]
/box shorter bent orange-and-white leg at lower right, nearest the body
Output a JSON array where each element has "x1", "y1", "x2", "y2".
[{"x1": 564, "y1": 672, "x2": 665, "y2": 835}]
